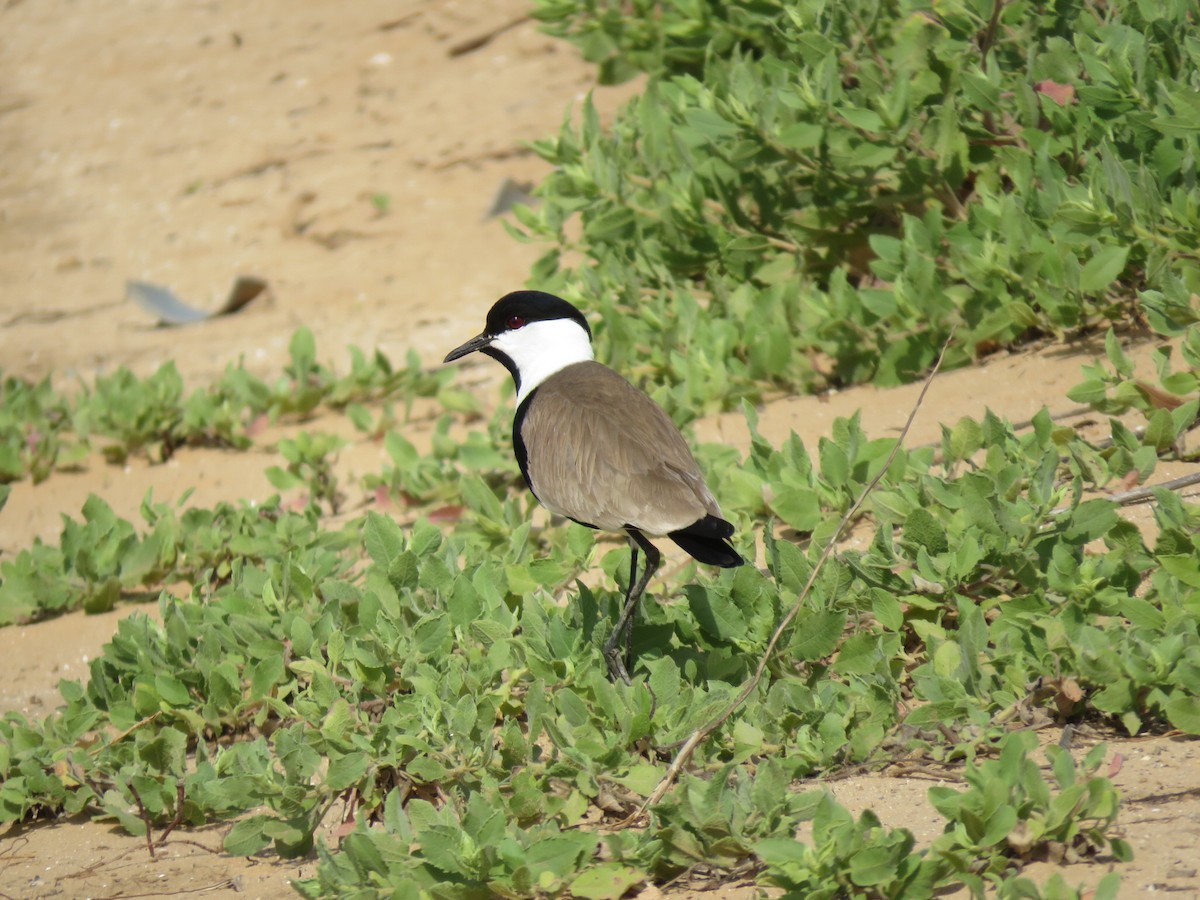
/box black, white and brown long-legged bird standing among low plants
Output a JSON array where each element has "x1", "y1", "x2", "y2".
[{"x1": 444, "y1": 290, "x2": 744, "y2": 684}]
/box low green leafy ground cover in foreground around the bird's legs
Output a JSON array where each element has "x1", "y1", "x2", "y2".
[{"x1": 0, "y1": 379, "x2": 1200, "y2": 896}]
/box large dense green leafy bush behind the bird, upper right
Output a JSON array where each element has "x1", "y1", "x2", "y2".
[{"x1": 514, "y1": 0, "x2": 1200, "y2": 419}]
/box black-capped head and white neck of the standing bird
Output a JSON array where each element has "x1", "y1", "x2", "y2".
[{"x1": 443, "y1": 290, "x2": 594, "y2": 404}]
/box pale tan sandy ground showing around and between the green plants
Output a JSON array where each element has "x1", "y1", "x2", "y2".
[{"x1": 0, "y1": 0, "x2": 1200, "y2": 898}]
